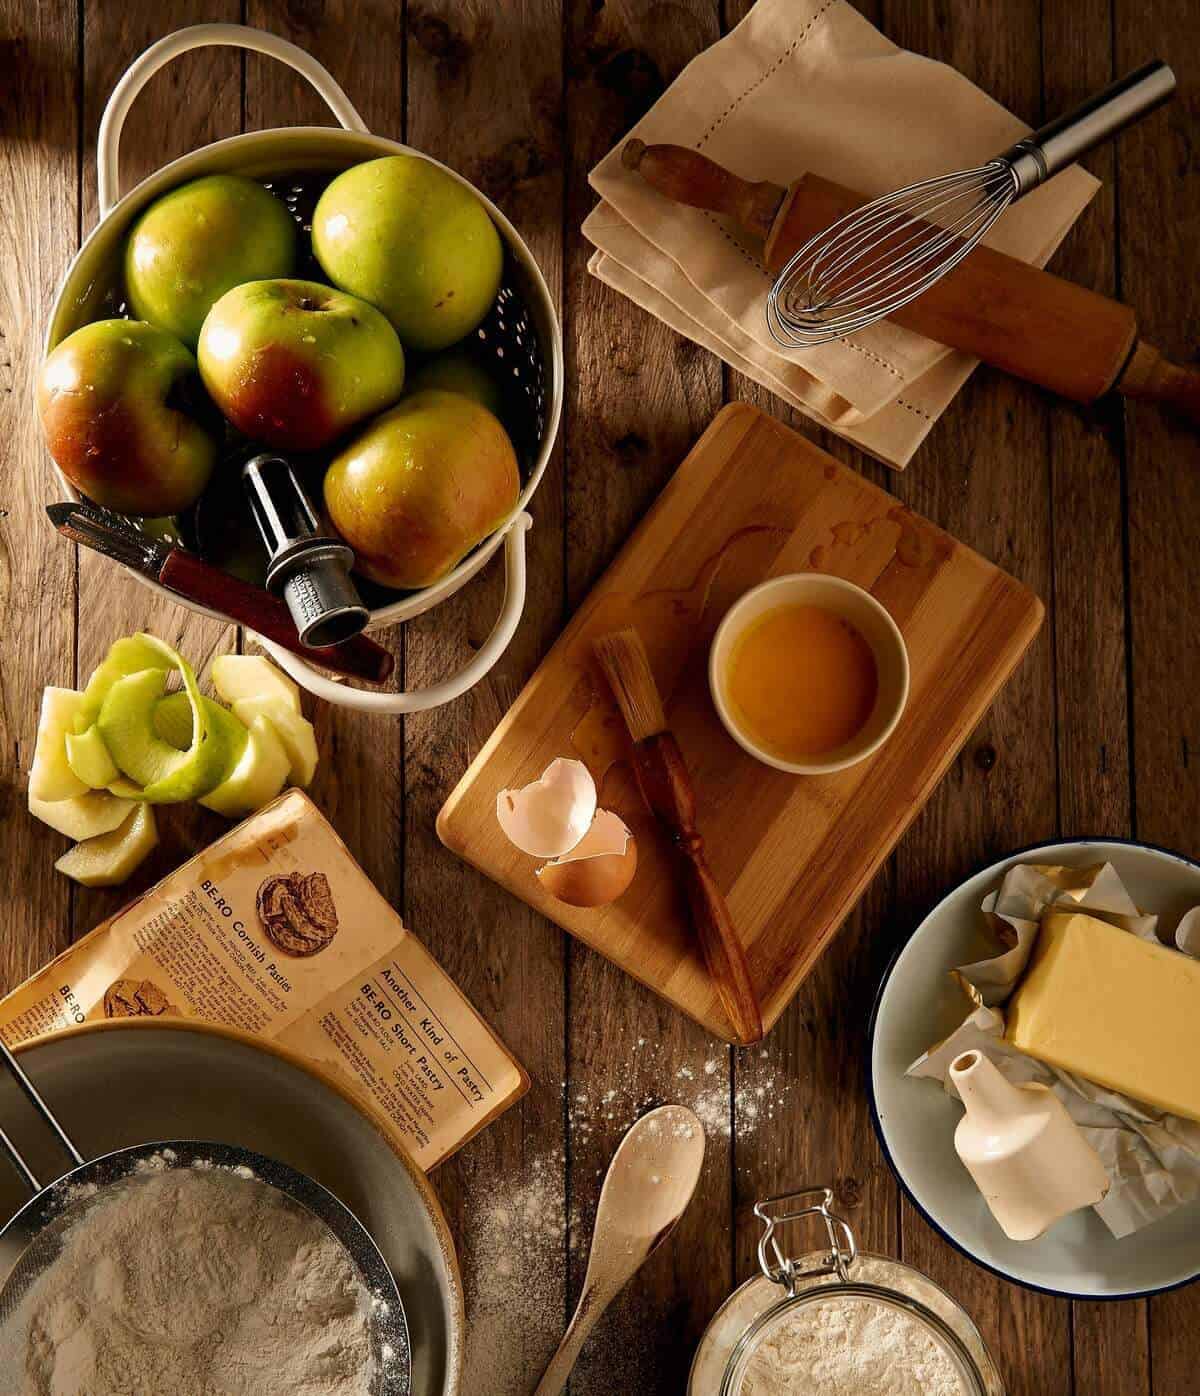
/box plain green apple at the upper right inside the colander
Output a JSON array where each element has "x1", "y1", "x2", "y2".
[{"x1": 313, "y1": 155, "x2": 504, "y2": 350}]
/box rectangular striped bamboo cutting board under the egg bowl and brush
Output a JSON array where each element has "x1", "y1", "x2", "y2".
[{"x1": 438, "y1": 403, "x2": 1042, "y2": 1040}]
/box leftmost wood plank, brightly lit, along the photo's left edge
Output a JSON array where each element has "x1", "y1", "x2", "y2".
[{"x1": 0, "y1": 0, "x2": 81, "y2": 991}]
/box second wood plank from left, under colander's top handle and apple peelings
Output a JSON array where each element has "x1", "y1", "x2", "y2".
[{"x1": 74, "y1": 0, "x2": 241, "y2": 934}]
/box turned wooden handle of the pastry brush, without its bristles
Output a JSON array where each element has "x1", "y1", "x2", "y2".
[{"x1": 633, "y1": 732, "x2": 763, "y2": 1044}]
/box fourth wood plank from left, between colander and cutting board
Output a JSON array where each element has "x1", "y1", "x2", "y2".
[{"x1": 405, "y1": 0, "x2": 569, "y2": 1393}]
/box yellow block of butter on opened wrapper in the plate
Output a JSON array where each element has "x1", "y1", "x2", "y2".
[{"x1": 1005, "y1": 912, "x2": 1200, "y2": 1120}]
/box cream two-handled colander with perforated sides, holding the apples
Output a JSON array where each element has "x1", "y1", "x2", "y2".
[{"x1": 45, "y1": 24, "x2": 562, "y2": 713}]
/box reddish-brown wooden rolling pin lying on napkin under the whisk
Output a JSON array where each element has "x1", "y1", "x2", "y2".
[{"x1": 622, "y1": 140, "x2": 1200, "y2": 424}]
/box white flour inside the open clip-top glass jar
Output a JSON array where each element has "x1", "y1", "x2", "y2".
[{"x1": 738, "y1": 1297, "x2": 967, "y2": 1396}]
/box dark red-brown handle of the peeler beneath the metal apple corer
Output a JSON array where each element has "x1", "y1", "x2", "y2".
[{"x1": 158, "y1": 547, "x2": 396, "y2": 684}]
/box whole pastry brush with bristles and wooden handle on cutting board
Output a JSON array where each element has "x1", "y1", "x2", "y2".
[{"x1": 593, "y1": 630, "x2": 763, "y2": 1043}]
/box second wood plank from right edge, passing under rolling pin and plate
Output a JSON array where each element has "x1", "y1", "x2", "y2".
[{"x1": 1042, "y1": 0, "x2": 1150, "y2": 1396}]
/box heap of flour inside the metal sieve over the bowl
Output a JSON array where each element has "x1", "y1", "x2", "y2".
[{"x1": 0, "y1": 1164, "x2": 373, "y2": 1396}]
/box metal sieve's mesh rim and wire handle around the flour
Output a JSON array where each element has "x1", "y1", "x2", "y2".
[{"x1": 0, "y1": 1039, "x2": 412, "y2": 1396}]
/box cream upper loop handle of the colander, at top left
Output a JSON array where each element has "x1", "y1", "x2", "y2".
[{"x1": 96, "y1": 24, "x2": 367, "y2": 218}]
